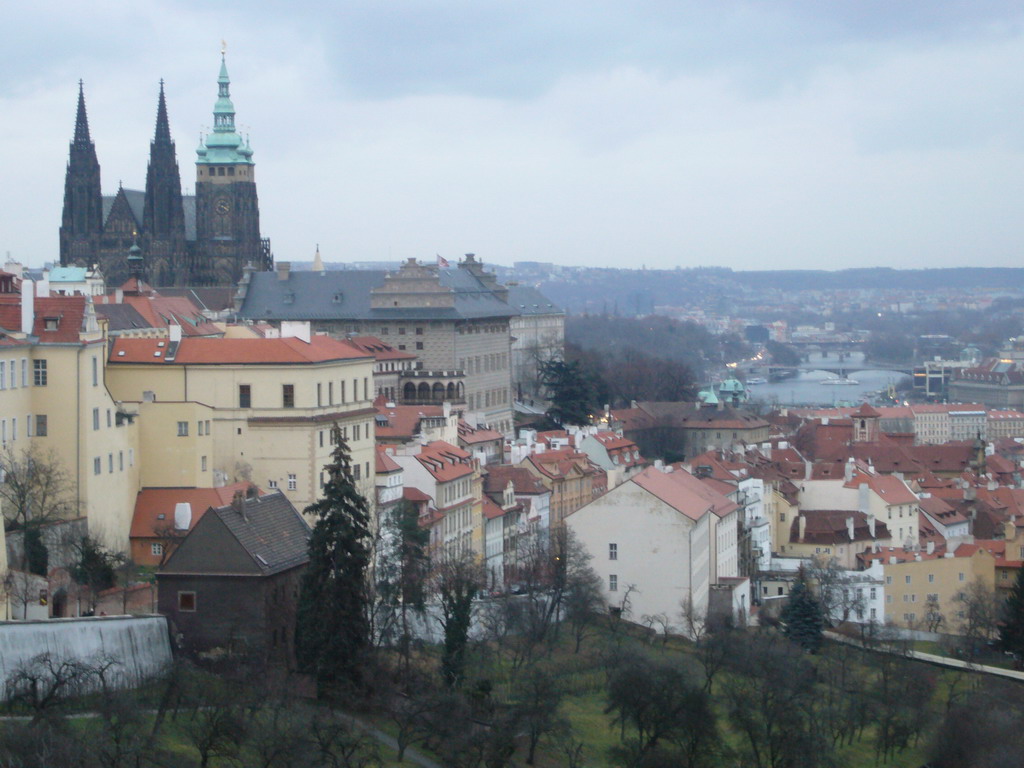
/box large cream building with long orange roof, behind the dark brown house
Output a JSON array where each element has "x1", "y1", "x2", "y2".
[{"x1": 109, "y1": 324, "x2": 376, "y2": 518}]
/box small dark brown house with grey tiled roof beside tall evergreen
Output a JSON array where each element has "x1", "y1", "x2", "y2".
[{"x1": 157, "y1": 490, "x2": 310, "y2": 669}]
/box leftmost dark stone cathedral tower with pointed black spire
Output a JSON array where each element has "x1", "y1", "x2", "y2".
[{"x1": 60, "y1": 80, "x2": 103, "y2": 266}]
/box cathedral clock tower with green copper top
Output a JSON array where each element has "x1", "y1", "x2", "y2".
[{"x1": 191, "y1": 51, "x2": 270, "y2": 286}]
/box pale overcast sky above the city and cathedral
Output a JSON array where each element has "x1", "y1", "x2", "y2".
[{"x1": 0, "y1": 0, "x2": 1024, "y2": 269}]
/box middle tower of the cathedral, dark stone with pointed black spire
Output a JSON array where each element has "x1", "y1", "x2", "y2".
[{"x1": 139, "y1": 80, "x2": 187, "y2": 286}]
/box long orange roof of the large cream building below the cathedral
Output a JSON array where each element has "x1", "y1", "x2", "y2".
[{"x1": 110, "y1": 336, "x2": 367, "y2": 366}]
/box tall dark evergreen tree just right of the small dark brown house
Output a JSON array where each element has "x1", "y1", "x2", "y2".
[{"x1": 295, "y1": 424, "x2": 370, "y2": 692}]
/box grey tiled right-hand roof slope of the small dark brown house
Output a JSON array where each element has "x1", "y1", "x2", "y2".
[{"x1": 207, "y1": 490, "x2": 311, "y2": 575}]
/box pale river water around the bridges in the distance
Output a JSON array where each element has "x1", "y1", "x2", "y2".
[{"x1": 750, "y1": 352, "x2": 910, "y2": 406}]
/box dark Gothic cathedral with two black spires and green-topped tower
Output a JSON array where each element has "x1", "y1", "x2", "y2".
[{"x1": 60, "y1": 57, "x2": 273, "y2": 287}]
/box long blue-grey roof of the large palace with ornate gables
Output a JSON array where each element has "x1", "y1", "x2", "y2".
[{"x1": 239, "y1": 267, "x2": 519, "y2": 321}]
